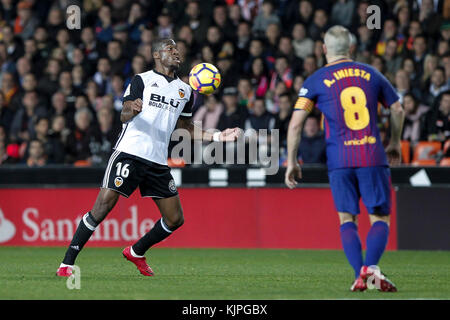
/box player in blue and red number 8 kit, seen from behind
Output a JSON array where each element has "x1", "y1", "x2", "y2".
[{"x1": 285, "y1": 26, "x2": 404, "y2": 291}]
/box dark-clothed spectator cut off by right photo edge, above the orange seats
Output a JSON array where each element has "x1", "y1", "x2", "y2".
[{"x1": 423, "y1": 91, "x2": 450, "y2": 141}]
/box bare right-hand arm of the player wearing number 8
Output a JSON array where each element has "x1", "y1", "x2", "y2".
[{"x1": 386, "y1": 101, "x2": 405, "y2": 166}]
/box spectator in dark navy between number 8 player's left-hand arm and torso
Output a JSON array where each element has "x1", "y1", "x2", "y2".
[{"x1": 298, "y1": 116, "x2": 326, "y2": 163}]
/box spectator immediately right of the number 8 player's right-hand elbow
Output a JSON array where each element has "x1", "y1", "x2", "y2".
[{"x1": 402, "y1": 92, "x2": 429, "y2": 146}]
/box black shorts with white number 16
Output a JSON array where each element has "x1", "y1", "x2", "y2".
[{"x1": 102, "y1": 150, "x2": 178, "y2": 198}]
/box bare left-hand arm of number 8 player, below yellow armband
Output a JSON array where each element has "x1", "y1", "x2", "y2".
[{"x1": 284, "y1": 110, "x2": 308, "y2": 189}]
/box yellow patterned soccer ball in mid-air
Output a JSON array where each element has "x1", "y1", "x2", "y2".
[{"x1": 189, "y1": 63, "x2": 221, "y2": 94}]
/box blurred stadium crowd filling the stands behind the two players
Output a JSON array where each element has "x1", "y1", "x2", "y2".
[{"x1": 0, "y1": 0, "x2": 450, "y2": 166}]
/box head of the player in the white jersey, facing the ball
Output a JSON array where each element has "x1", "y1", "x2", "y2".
[{"x1": 152, "y1": 39, "x2": 181, "y2": 70}]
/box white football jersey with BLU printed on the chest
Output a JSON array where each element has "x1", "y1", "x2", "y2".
[{"x1": 114, "y1": 70, "x2": 194, "y2": 165}]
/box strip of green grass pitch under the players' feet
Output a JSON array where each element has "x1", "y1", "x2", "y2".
[{"x1": 0, "y1": 247, "x2": 450, "y2": 300}]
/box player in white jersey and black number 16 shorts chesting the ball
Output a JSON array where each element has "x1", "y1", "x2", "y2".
[{"x1": 56, "y1": 39, "x2": 240, "y2": 277}]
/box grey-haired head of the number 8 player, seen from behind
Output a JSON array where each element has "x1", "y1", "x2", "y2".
[{"x1": 323, "y1": 26, "x2": 351, "y2": 60}]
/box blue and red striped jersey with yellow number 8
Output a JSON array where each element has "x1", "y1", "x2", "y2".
[{"x1": 294, "y1": 59, "x2": 399, "y2": 170}]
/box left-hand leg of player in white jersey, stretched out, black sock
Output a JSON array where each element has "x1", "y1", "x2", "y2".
[{"x1": 62, "y1": 188, "x2": 119, "y2": 266}]
